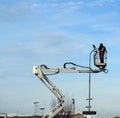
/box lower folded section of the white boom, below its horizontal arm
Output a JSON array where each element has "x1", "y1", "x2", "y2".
[{"x1": 33, "y1": 66, "x2": 65, "y2": 118}]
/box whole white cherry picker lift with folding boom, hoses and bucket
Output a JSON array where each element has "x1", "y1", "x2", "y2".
[{"x1": 33, "y1": 46, "x2": 107, "y2": 118}]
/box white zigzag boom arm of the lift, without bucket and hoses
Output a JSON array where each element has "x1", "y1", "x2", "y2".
[{"x1": 33, "y1": 66, "x2": 101, "y2": 118}]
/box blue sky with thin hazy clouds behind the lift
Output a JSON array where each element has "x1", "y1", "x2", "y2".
[{"x1": 0, "y1": 0, "x2": 120, "y2": 115}]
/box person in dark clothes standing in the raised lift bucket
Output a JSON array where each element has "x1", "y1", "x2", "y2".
[{"x1": 98, "y1": 43, "x2": 107, "y2": 63}]
